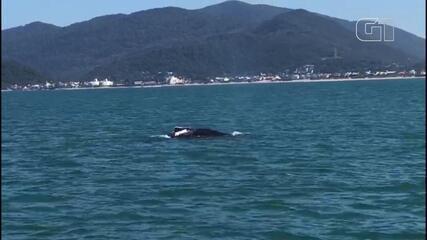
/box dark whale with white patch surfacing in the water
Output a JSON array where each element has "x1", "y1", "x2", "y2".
[{"x1": 168, "y1": 127, "x2": 231, "y2": 138}]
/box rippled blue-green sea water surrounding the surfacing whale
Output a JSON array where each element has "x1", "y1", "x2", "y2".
[{"x1": 1, "y1": 79, "x2": 426, "y2": 240}]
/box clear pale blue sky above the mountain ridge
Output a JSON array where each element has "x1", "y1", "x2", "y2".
[{"x1": 1, "y1": 0, "x2": 426, "y2": 38}]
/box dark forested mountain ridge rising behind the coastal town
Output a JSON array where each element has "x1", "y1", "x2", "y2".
[{"x1": 2, "y1": 1, "x2": 425, "y2": 84}]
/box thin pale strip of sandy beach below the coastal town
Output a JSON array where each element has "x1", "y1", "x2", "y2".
[{"x1": 1, "y1": 76, "x2": 426, "y2": 92}]
